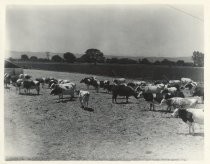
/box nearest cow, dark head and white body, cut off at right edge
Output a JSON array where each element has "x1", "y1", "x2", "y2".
[{"x1": 172, "y1": 108, "x2": 204, "y2": 134}]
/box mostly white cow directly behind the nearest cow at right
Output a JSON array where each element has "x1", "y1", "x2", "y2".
[{"x1": 160, "y1": 97, "x2": 198, "y2": 111}]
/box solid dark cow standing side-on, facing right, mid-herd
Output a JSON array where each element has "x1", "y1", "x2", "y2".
[{"x1": 112, "y1": 85, "x2": 139, "y2": 103}]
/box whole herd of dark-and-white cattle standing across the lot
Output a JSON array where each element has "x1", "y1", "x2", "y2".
[{"x1": 4, "y1": 74, "x2": 204, "y2": 133}]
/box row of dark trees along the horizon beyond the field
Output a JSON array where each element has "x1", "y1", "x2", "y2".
[{"x1": 9, "y1": 48, "x2": 204, "y2": 67}]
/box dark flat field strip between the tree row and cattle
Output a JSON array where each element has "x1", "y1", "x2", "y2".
[{"x1": 13, "y1": 61, "x2": 204, "y2": 82}]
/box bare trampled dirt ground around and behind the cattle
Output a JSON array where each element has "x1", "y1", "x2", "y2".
[{"x1": 4, "y1": 70, "x2": 204, "y2": 160}]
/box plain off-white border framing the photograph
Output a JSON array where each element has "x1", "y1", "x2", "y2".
[{"x1": 0, "y1": 0, "x2": 210, "y2": 164}]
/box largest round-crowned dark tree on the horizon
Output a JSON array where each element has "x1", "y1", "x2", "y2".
[{"x1": 81, "y1": 48, "x2": 105, "y2": 65}]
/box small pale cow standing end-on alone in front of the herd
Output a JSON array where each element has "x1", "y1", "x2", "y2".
[{"x1": 75, "y1": 90, "x2": 90, "y2": 108}]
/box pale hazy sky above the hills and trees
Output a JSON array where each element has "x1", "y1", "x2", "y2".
[{"x1": 6, "y1": 5, "x2": 204, "y2": 57}]
